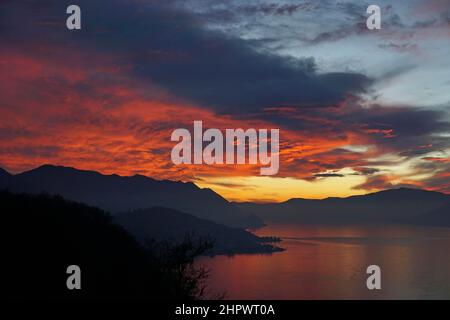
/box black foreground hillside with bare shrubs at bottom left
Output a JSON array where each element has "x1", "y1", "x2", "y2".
[{"x1": 0, "y1": 191, "x2": 210, "y2": 299}]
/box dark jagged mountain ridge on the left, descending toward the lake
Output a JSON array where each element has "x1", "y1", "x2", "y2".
[{"x1": 0, "y1": 165, "x2": 263, "y2": 228}]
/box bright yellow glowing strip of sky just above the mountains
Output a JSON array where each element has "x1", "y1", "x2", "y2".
[{"x1": 195, "y1": 176, "x2": 367, "y2": 202}]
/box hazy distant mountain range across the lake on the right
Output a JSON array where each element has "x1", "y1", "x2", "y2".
[{"x1": 236, "y1": 188, "x2": 450, "y2": 226}]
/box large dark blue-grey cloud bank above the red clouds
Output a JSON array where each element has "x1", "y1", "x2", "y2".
[{"x1": 0, "y1": 0, "x2": 370, "y2": 113}]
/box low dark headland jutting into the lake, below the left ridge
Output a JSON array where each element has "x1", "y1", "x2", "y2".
[{"x1": 114, "y1": 207, "x2": 281, "y2": 254}]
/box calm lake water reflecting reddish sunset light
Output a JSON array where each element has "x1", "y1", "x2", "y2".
[{"x1": 199, "y1": 224, "x2": 450, "y2": 299}]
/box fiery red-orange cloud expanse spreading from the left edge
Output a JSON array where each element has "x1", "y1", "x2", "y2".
[{"x1": 0, "y1": 42, "x2": 448, "y2": 201}]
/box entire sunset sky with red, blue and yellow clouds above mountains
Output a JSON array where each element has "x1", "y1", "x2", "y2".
[{"x1": 0, "y1": 0, "x2": 450, "y2": 202}]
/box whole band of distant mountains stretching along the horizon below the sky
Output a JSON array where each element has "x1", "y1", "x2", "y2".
[{"x1": 4, "y1": 165, "x2": 450, "y2": 228}]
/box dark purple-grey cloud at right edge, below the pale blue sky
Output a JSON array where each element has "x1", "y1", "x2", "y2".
[{"x1": 280, "y1": 102, "x2": 450, "y2": 157}]
